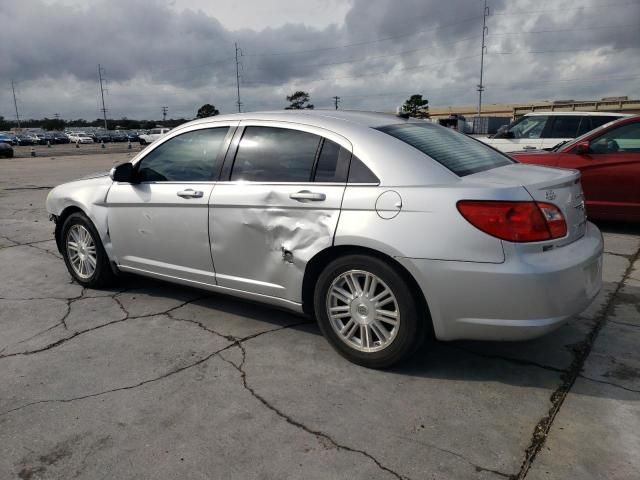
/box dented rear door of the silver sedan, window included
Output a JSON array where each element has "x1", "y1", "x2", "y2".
[{"x1": 209, "y1": 122, "x2": 351, "y2": 302}]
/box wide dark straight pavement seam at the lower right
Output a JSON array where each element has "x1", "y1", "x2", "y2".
[{"x1": 514, "y1": 246, "x2": 640, "y2": 480}]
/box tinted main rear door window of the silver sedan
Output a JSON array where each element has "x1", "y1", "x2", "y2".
[{"x1": 231, "y1": 126, "x2": 322, "y2": 182}]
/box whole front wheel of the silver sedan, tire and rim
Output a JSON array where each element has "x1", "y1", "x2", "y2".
[{"x1": 62, "y1": 212, "x2": 114, "y2": 288}]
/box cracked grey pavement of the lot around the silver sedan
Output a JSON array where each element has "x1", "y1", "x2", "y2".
[{"x1": 0, "y1": 152, "x2": 640, "y2": 480}]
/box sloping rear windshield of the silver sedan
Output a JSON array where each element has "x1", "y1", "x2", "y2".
[{"x1": 377, "y1": 122, "x2": 515, "y2": 177}]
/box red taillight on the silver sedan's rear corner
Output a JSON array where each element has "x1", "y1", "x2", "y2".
[{"x1": 457, "y1": 200, "x2": 567, "y2": 242}]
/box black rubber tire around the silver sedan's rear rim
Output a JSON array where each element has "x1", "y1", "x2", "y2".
[{"x1": 314, "y1": 255, "x2": 430, "y2": 368}]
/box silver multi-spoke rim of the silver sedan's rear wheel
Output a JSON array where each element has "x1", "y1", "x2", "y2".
[{"x1": 327, "y1": 270, "x2": 400, "y2": 352}]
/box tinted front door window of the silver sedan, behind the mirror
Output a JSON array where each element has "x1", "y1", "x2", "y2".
[{"x1": 138, "y1": 127, "x2": 229, "y2": 182}]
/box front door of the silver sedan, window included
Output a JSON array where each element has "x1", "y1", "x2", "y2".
[{"x1": 107, "y1": 126, "x2": 234, "y2": 284}]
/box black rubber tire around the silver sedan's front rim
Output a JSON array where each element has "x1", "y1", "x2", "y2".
[{"x1": 60, "y1": 212, "x2": 115, "y2": 288}]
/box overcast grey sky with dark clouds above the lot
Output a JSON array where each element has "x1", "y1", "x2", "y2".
[{"x1": 0, "y1": 0, "x2": 640, "y2": 120}]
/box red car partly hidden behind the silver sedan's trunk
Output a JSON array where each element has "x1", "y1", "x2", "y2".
[{"x1": 509, "y1": 116, "x2": 640, "y2": 222}]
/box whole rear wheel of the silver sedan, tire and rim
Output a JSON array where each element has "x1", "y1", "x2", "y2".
[{"x1": 314, "y1": 255, "x2": 426, "y2": 368}]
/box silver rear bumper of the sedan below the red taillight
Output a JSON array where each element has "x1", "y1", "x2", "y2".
[{"x1": 397, "y1": 223, "x2": 603, "y2": 340}]
